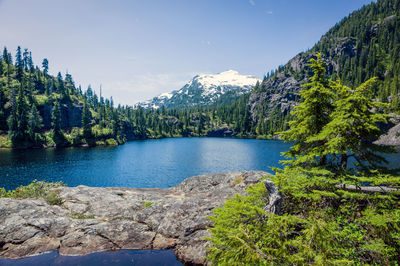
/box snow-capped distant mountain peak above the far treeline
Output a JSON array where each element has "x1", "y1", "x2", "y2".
[{"x1": 136, "y1": 70, "x2": 261, "y2": 109}]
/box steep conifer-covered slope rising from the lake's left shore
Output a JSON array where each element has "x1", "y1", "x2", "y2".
[{"x1": 0, "y1": 47, "x2": 141, "y2": 148}]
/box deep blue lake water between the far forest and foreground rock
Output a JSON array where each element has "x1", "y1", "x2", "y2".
[{"x1": 0, "y1": 138, "x2": 290, "y2": 189}]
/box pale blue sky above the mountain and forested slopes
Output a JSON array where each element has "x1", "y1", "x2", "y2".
[{"x1": 0, "y1": 0, "x2": 371, "y2": 105}]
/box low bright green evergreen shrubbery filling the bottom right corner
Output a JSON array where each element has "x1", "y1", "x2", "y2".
[{"x1": 207, "y1": 169, "x2": 400, "y2": 265}]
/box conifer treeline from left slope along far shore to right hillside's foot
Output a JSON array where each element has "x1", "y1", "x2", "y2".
[{"x1": 0, "y1": 47, "x2": 252, "y2": 148}]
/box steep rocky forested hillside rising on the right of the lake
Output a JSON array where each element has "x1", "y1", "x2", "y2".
[{"x1": 249, "y1": 0, "x2": 400, "y2": 134}]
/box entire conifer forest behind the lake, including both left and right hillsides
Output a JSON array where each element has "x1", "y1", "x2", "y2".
[{"x1": 0, "y1": 0, "x2": 400, "y2": 147}]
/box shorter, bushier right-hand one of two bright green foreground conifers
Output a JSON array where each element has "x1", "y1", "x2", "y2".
[{"x1": 307, "y1": 78, "x2": 393, "y2": 171}]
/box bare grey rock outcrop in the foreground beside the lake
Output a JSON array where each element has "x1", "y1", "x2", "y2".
[{"x1": 0, "y1": 171, "x2": 272, "y2": 264}]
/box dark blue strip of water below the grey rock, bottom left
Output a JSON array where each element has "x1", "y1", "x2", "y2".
[{"x1": 0, "y1": 250, "x2": 182, "y2": 266}]
